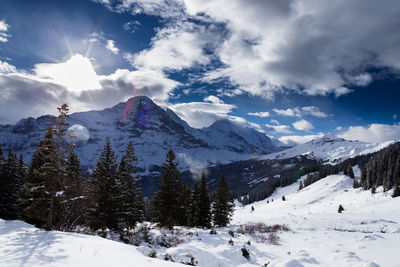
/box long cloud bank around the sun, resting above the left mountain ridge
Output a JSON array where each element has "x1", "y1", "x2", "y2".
[{"x1": 0, "y1": 55, "x2": 179, "y2": 124}]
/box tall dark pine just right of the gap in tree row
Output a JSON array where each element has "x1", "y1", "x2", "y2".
[{"x1": 153, "y1": 149, "x2": 180, "y2": 229}]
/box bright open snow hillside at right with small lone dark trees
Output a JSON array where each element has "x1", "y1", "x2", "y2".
[{"x1": 233, "y1": 172, "x2": 400, "y2": 267}]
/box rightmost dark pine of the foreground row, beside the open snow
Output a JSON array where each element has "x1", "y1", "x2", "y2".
[{"x1": 212, "y1": 175, "x2": 234, "y2": 227}]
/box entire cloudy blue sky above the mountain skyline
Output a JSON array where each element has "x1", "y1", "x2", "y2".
[{"x1": 0, "y1": 0, "x2": 400, "y2": 147}]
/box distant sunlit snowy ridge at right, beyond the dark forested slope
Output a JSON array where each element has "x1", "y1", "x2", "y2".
[{"x1": 260, "y1": 134, "x2": 394, "y2": 163}]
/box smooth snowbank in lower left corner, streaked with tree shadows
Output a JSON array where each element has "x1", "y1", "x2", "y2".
[{"x1": 0, "y1": 219, "x2": 182, "y2": 267}]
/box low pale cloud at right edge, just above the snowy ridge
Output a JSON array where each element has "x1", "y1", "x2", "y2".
[{"x1": 338, "y1": 123, "x2": 400, "y2": 143}]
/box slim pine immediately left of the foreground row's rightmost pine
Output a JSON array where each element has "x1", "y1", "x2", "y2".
[{"x1": 196, "y1": 172, "x2": 211, "y2": 228}]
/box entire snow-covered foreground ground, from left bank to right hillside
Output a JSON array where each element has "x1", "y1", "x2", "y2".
[{"x1": 0, "y1": 170, "x2": 400, "y2": 267}]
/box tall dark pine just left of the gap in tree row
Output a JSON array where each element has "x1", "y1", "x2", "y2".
[{"x1": 116, "y1": 142, "x2": 144, "y2": 232}]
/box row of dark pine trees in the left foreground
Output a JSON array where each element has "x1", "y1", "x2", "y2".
[{"x1": 0, "y1": 104, "x2": 233, "y2": 233}]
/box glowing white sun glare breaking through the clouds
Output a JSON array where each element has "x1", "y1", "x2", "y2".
[{"x1": 35, "y1": 54, "x2": 101, "y2": 93}]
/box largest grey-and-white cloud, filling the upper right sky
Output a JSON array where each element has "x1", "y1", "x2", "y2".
[{"x1": 184, "y1": 0, "x2": 400, "y2": 98}]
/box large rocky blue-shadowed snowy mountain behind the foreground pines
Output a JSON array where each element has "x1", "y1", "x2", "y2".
[{"x1": 0, "y1": 96, "x2": 279, "y2": 173}]
